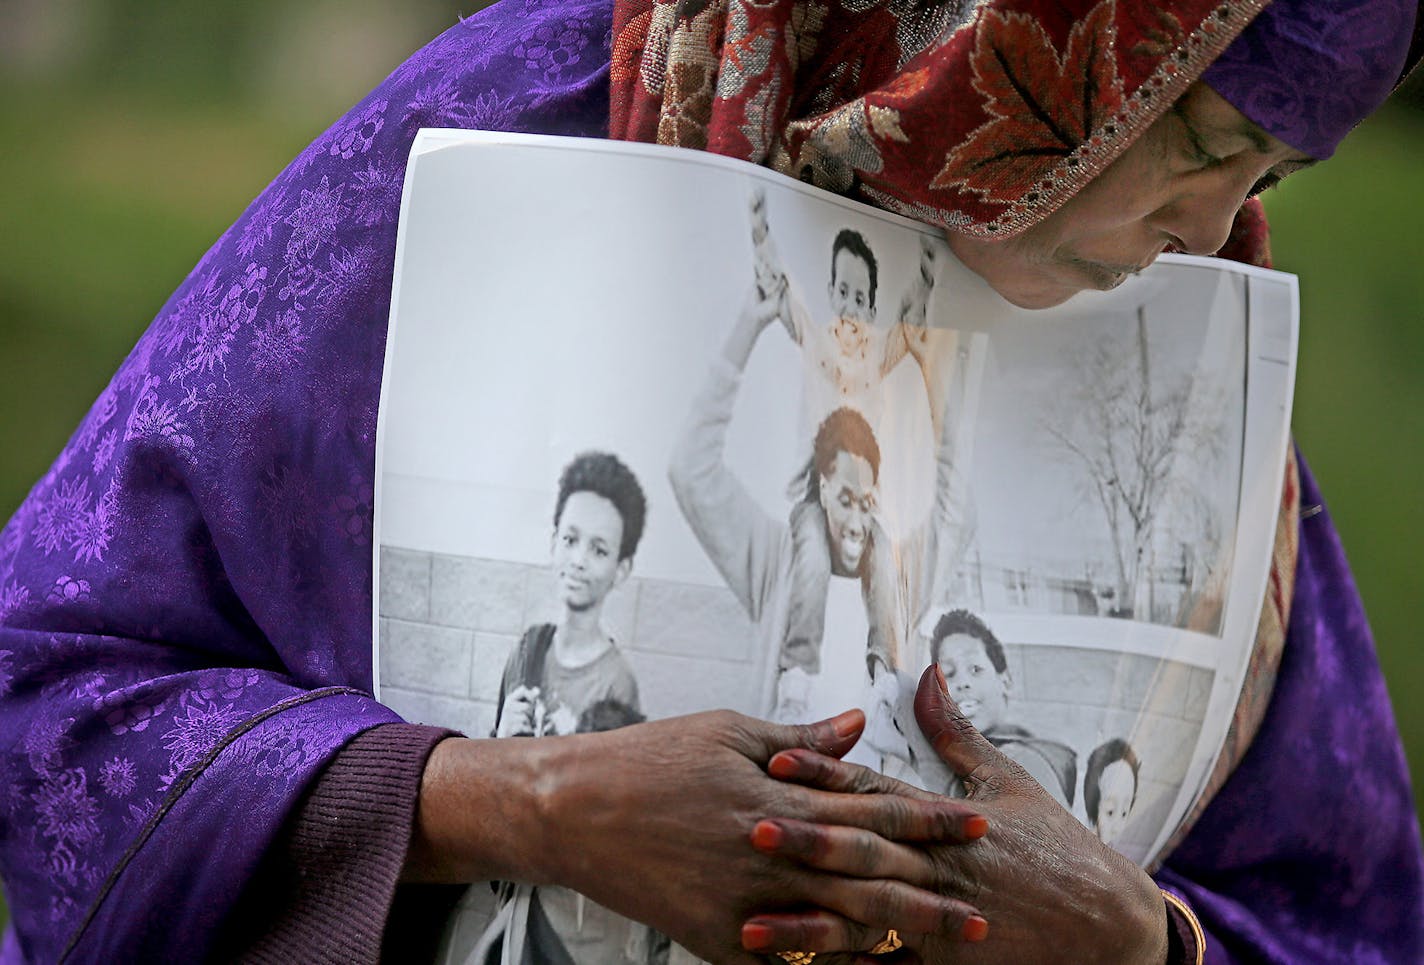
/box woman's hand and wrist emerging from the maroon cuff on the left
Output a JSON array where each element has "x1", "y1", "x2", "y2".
[{"x1": 406, "y1": 710, "x2": 984, "y2": 965}]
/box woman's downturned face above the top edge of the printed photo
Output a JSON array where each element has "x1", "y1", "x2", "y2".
[{"x1": 948, "y1": 83, "x2": 1313, "y2": 309}]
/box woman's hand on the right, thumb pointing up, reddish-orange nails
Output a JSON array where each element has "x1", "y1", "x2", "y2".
[{"x1": 742, "y1": 666, "x2": 1168, "y2": 965}]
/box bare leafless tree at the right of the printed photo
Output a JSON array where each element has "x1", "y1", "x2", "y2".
[{"x1": 1041, "y1": 307, "x2": 1223, "y2": 619}]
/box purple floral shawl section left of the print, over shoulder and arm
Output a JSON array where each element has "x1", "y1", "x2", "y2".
[{"x1": 0, "y1": 0, "x2": 611, "y2": 961}]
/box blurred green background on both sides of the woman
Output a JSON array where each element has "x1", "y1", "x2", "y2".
[{"x1": 0, "y1": 0, "x2": 1424, "y2": 939}]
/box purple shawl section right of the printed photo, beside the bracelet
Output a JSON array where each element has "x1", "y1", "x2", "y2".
[{"x1": 1158, "y1": 463, "x2": 1424, "y2": 965}]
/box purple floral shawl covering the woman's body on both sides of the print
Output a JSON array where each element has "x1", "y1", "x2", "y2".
[{"x1": 0, "y1": 0, "x2": 1424, "y2": 962}]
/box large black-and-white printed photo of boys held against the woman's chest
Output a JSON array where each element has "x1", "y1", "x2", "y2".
[{"x1": 373, "y1": 132, "x2": 1292, "y2": 964}]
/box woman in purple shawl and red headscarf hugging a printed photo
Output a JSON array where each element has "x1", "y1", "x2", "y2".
[{"x1": 0, "y1": 0, "x2": 1424, "y2": 962}]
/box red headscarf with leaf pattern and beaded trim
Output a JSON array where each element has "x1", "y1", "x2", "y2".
[{"x1": 609, "y1": 0, "x2": 1266, "y2": 238}]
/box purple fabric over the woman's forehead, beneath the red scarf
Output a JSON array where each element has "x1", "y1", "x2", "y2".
[{"x1": 1202, "y1": 0, "x2": 1418, "y2": 159}]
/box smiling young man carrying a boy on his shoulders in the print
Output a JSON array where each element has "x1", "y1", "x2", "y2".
[{"x1": 669, "y1": 280, "x2": 954, "y2": 766}]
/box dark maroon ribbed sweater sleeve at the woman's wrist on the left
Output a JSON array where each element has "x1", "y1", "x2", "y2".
[{"x1": 218, "y1": 723, "x2": 463, "y2": 962}]
